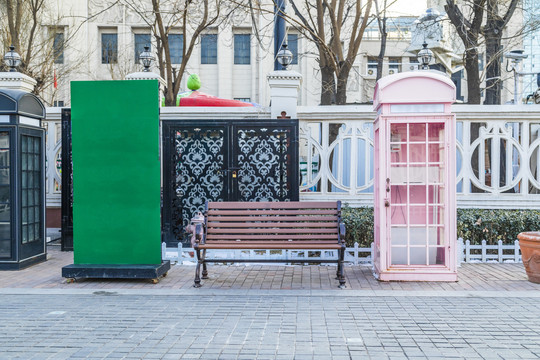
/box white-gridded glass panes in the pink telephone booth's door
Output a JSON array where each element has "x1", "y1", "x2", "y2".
[{"x1": 386, "y1": 119, "x2": 448, "y2": 267}]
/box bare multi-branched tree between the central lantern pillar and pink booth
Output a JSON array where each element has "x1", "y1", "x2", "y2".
[{"x1": 287, "y1": 0, "x2": 372, "y2": 105}]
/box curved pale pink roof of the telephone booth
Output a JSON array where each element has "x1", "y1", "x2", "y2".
[{"x1": 373, "y1": 70, "x2": 456, "y2": 110}]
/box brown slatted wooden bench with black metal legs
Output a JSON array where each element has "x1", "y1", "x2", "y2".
[{"x1": 193, "y1": 201, "x2": 345, "y2": 288}]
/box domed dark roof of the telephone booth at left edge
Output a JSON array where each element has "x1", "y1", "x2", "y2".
[{"x1": 0, "y1": 89, "x2": 45, "y2": 119}]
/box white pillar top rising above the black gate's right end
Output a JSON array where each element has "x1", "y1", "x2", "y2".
[{"x1": 267, "y1": 70, "x2": 302, "y2": 119}]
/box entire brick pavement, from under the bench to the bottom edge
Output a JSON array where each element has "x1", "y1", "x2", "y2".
[{"x1": 0, "y1": 243, "x2": 540, "y2": 360}]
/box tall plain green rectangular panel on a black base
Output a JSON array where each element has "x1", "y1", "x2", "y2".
[{"x1": 71, "y1": 80, "x2": 161, "y2": 265}]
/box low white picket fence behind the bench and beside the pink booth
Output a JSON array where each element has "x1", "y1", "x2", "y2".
[{"x1": 161, "y1": 238, "x2": 522, "y2": 265}]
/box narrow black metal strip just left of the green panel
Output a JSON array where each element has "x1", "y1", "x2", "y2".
[{"x1": 61, "y1": 109, "x2": 73, "y2": 251}]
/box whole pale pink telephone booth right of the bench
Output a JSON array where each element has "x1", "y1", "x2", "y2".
[{"x1": 373, "y1": 70, "x2": 457, "y2": 281}]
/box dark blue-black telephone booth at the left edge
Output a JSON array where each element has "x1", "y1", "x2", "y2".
[{"x1": 0, "y1": 89, "x2": 47, "y2": 270}]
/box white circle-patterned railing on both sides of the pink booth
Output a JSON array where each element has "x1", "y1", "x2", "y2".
[{"x1": 298, "y1": 105, "x2": 540, "y2": 209}]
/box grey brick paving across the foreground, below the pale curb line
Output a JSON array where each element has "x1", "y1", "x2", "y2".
[{"x1": 0, "y1": 290, "x2": 540, "y2": 360}]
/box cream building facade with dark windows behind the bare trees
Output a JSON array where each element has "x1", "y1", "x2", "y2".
[{"x1": 10, "y1": 0, "x2": 524, "y2": 106}]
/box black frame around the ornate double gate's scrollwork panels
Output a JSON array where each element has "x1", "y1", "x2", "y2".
[{"x1": 162, "y1": 119, "x2": 299, "y2": 247}]
